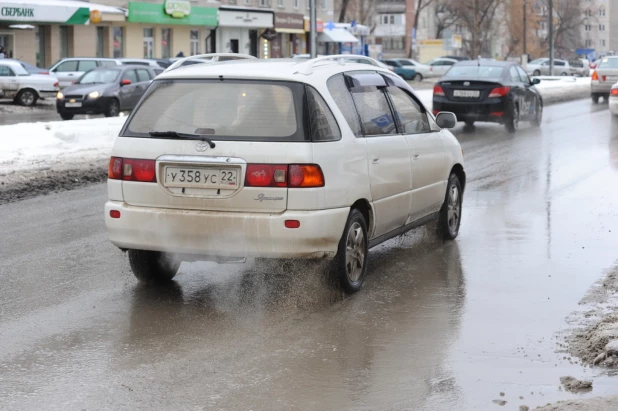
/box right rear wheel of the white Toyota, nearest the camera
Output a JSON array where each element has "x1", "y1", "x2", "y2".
[{"x1": 333, "y1": 209, "x2": 369, "y2": 294}]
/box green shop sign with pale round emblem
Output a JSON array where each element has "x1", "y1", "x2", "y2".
[{"x1": 127, "y1": 0, "x2": 219, "y2": 27}]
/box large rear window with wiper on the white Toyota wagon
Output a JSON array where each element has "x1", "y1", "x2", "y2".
[{"x1": 123, "y1": 79, "x2": 311, "y2": 141}]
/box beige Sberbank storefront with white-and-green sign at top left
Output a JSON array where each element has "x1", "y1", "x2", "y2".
[{"x1": 0, "y1": 0, "x2": 125, "y2": 67}]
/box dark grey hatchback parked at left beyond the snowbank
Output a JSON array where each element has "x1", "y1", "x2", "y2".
[{"x1": 56, "y1": 66, "x2": 156, "y2": 120}]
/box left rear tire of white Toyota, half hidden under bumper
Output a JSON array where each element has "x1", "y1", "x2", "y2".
[{"x1": 129, "y1": 250, "x2": 180, "y2": 284}]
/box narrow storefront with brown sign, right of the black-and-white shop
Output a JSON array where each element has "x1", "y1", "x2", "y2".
[{"x1": 271, "y1": 13, "x2": 306, "y2": 58}]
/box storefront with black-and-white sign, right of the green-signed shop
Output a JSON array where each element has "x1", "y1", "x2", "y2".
[{"x1": 217, "y1": 6, "x2": 274, "y2": 58}]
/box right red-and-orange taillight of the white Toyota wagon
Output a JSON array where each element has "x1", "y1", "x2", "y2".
[{"x1": 245, "y1": 164, "x2": 324, "y2": 188}]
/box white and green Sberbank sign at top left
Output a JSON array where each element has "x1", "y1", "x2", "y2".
[{"x1": 0, "y1": 1, "x2": 90, "y2": 24}]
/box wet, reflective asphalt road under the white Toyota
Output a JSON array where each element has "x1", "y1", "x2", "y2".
[{"x1": 0, "y1": 100, "x2": 618, "y2": 410}]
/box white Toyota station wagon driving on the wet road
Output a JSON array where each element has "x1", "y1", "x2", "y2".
[{"x1": 105, "y1": 56, "x2": 466, "y2": 292}]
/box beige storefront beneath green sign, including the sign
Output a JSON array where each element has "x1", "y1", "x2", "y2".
[{"x1": 126, "y1": 0, "x2": 218, "y2": 59}]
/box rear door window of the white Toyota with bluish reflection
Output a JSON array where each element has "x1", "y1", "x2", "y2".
[{"x1": 352, "y1": 86, "x2": 397, "y2": 136}]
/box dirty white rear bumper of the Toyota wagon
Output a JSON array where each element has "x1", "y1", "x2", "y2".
[{"x1": 105, "y1": 201, "x2": 350, "y2": 258}]
